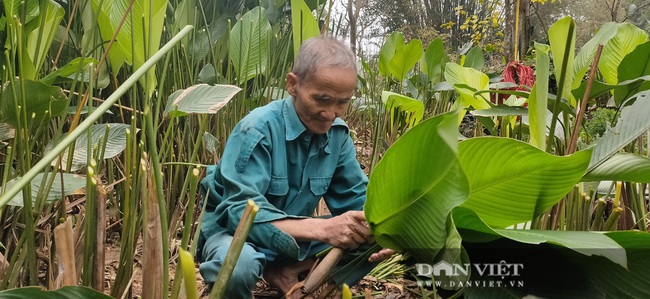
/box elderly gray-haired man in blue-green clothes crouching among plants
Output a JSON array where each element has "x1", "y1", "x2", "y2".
[{"x1": 198, "y1": 37, "x2": 390, "y2": 298}]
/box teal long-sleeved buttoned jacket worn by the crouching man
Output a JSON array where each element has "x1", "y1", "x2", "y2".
[{"x1": 197, "y1": 97, "x2": 368, "y2": 260}]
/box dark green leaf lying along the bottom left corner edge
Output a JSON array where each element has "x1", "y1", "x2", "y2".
[{"x1": 0, "y1": 286, "x2": 111, "y2": 299}]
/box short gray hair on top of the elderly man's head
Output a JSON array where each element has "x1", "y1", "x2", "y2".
[{"x1": 292, "y1": 35, "x2": 357, "y2": 81}]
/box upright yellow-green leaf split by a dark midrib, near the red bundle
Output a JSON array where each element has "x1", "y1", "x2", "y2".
[{"x1": 548, "y1": 17, "x2": 576, "y2": 106}]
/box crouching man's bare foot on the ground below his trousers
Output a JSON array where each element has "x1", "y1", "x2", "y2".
[{"x1": 264, "y1": 259, "x2": 315, "y2": 298}]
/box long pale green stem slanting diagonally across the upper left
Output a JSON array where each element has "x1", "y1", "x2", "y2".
[{"x1": 0, "y1": 25, "x2": 192, "y2": 208}]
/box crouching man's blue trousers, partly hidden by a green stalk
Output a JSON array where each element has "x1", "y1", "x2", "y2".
[{"x1": 199, "y1": 230, "x2": 377, "y2": 299}]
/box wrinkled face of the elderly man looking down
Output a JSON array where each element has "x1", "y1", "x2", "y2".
[{"x1": 287, "y1": 68, "x2": 357, "y2": 134}]
